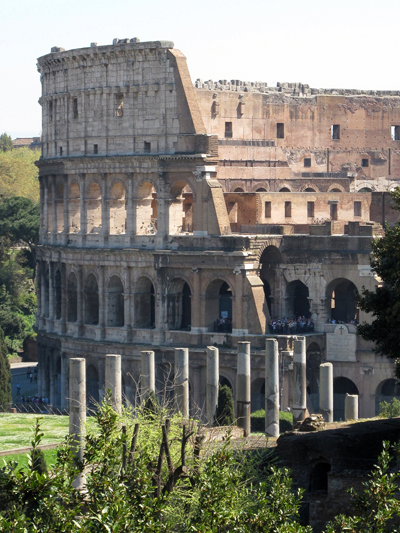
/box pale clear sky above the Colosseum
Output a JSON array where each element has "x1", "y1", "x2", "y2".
[{"x1": 0, "y1": 0, "x2": 400, "y2": 138}]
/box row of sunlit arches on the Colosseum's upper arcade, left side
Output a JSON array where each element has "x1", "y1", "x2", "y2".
[{"x1": 41, "y1": 180, "x2": 194, "y2": 235}]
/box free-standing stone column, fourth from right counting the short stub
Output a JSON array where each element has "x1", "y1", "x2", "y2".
[{"x1": 265, "y1": 339, "x2": 279, "y2": 437}]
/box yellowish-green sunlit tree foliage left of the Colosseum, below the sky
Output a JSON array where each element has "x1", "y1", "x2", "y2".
[{"x1": 0, "y1": 148, "x2": 40, "y2": 202}]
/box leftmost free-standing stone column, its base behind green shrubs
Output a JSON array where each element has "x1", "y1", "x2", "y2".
[{"x1": 69, "y1": 358, "x2": 86, "y2": 489}]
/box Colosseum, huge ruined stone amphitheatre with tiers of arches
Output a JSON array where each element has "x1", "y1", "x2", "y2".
[{"x1": 36, "y1": 38, "x2": 400, "y2": 420}]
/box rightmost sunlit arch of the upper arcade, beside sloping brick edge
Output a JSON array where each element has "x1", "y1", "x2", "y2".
[{"x1": 169, "y1": 181, "x2": 193, "y2": 235}]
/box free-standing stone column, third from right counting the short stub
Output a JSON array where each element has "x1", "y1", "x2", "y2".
[{"x1": 293, "y1": 337, "x2": 307, "y2": 424}]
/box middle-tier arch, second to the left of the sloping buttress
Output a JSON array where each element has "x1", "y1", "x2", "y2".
[{"x1": 167, "y1": 279, "x2": 192, "y2": 330}]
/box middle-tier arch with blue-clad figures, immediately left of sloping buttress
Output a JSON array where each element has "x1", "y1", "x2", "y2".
[{"x1": 206, "y1": 279, "x2": 232, "y2": 333}]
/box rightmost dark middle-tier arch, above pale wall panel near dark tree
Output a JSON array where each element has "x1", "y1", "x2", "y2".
[{"x1": 326, "y1": 278, "x2": 358, "y2": 322}]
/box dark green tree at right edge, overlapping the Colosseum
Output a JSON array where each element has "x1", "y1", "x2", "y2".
[{"x1": 358, "y1": 188, "x2": 400, "y2": 376}]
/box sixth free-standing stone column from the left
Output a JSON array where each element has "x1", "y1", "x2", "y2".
[{"x1": 236, "y1": 342, "x2": 251, "y2": 437}]
